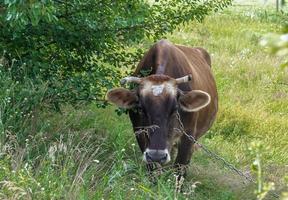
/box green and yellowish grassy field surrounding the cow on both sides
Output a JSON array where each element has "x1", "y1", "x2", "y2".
[{"x1": 0, "y1": 1, "x2": 288, "y2": 200}]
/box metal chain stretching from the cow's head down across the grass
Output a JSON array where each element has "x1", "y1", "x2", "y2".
[{"x1": 176, "y1": 111, "x2": 280, "y2": 198}]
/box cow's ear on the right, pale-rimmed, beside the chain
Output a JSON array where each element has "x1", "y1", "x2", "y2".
[{"x1": 178, "y1": 90, "x2": 211, "y2": 112}]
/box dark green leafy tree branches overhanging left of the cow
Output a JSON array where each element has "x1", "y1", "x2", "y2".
[{"x1": 0, "y1": 0, "x2": 231, "y2": 109}]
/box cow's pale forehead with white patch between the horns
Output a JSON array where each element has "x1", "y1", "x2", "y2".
[{"x1": 140, "y1": 80, "x2": 177, "y2": 97}]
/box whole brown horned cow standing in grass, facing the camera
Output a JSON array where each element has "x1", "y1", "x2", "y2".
[{"x1": 107, "y1": 40, "x2": 218, "y2": 177}]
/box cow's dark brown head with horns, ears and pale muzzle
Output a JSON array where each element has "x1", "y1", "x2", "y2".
[{"x1": 107, "y1": 75, "x2": 210, "y2": 163}]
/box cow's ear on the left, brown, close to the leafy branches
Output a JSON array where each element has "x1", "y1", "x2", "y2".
[{"x1": 106, "y1": 88, "x2": 138, "y2": 108}]
